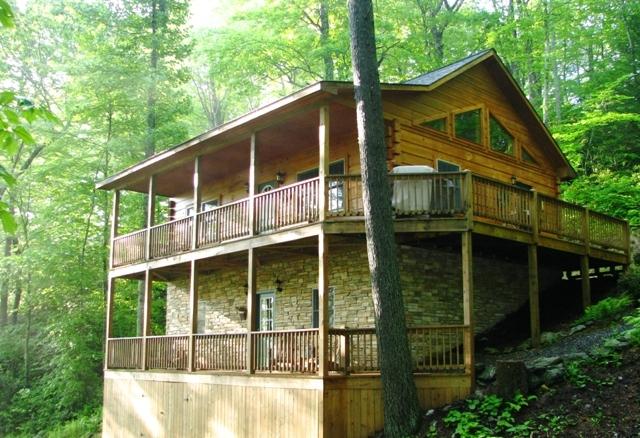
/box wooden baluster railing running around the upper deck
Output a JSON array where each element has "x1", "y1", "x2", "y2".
[{"x1": 113, "y1": 172, "x2": 629, "y2": 267}]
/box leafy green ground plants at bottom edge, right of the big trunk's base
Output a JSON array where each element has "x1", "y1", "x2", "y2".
[{"x1": 444, "y1": 394, "x2": 536, "y2": 438}]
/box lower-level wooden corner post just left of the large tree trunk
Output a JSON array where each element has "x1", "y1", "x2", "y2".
[{"x1": 318, "y1": 226, "x2": 329, "y2": 377}]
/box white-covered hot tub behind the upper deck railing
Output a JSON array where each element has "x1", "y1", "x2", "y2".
[{"x1": 391, "y1": 166, "x2": 435, "y2": 214}]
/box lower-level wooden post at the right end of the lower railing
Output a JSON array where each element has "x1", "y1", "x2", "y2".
[{"x1": 461, "y1": 231, "x2": 475, "y2": 384}]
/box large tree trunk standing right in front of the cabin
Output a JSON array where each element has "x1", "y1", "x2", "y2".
[{"x1": 348, "y1": 0, "x2": 420, "y2": 437}]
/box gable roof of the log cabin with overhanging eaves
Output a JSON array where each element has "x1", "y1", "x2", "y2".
[{"x1": 96, "y1": 49, "x2": 576, "y2": 189}]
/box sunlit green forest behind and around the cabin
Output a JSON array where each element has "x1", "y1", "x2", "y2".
[{"x1": 0, "y1": 0, "x2": 640, "y2": 436}]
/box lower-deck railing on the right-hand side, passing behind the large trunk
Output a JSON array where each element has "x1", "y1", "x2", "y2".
[{"x1": 329, "y1": 325, "x2": 469, "y2": 374}]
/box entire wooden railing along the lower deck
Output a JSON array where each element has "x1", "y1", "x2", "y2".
[{"x1": 106, "y1": 325, "x2": 464, "y2": 374}]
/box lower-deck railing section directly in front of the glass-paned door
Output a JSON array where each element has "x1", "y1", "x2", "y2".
[{"x1": 251, "y1": 329, "x2": 319, "y2": 373}]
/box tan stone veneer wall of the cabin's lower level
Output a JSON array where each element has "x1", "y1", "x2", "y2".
[{"x1": 167, "y1": 240, "x2": 550, "y2": 334}]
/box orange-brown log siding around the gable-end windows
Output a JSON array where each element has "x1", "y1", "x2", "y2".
[{"x1": 383, "y1": 64, "x2": 557, "y2": 196}]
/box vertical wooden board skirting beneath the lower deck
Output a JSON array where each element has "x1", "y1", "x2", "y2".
[{"x1": 102, "y1": 371, "x2": 471, "y2": 438}]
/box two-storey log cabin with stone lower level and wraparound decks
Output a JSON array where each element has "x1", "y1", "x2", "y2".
[{"x1": 98, "y1": 50, "x2": 629, "y2": 437}]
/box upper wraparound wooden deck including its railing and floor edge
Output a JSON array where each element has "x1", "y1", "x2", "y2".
[{"x1": 112, "y1": 172, "x2": 629, "y2": 269}]
